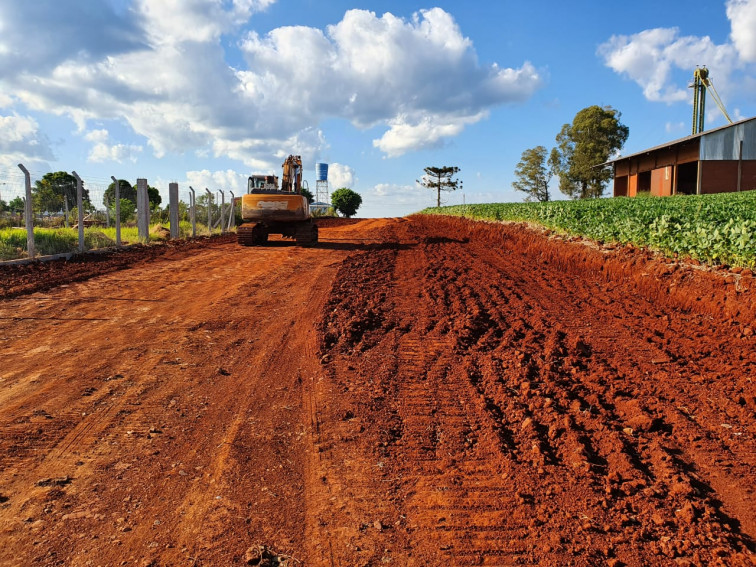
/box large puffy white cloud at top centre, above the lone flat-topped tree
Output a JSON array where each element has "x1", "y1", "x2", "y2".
[{"x1": 239, "y1": 8, "x2": 542, "y2": 157}]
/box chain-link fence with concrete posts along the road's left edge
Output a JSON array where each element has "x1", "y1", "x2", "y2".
[{"x1": 0, "y1": 164, "x2": 239, "y2": 261}]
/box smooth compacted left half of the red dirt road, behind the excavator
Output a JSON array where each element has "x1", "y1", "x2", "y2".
[{"x1": 0, "y1": 223, "x2": 380, "y2": 565}]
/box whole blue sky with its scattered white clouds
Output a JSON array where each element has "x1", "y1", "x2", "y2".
[{"x1": 0, "y1": 0, "x2": 756, "y2": 216}]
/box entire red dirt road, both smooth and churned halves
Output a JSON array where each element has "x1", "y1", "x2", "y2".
[{"x1": 0, "y1": 218, "x2": 756, "y2": 567}]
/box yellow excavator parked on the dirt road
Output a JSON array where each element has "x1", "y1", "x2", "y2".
[{"x1": 236, "y1": 156, "x2": 318, "y2": 246}]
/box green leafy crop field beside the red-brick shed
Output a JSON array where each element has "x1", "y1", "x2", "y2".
[{"x1": 421, "y1": 191, "x2": 756, "y2": 268}]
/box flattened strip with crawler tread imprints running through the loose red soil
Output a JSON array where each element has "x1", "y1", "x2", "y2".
[{"x1": 386, "y1": 241, "x2": 527, "y2": 563}]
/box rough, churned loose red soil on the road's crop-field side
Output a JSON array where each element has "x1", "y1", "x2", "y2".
[{"x1": 322, "y1": 217, "x2": 756, "y2": 565}]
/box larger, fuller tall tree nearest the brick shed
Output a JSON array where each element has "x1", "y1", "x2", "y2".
[{"x1": 549, "y1": 105, "x2": 630, "y2": 199}]
